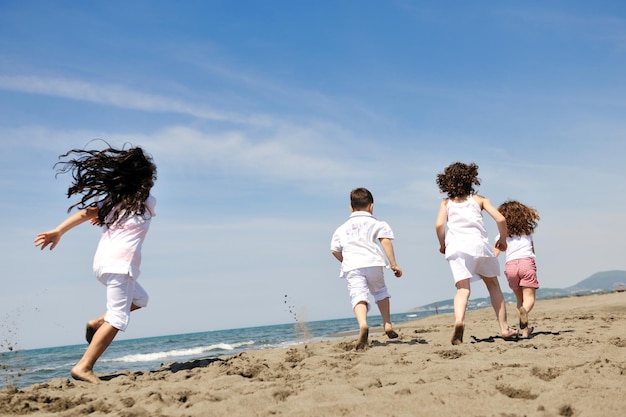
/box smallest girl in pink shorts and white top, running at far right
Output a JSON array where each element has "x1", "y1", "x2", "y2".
[{"x1": 495, "y1": 200, "x2": 539, "y2": 337}]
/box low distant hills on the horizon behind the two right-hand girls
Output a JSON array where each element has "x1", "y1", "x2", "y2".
[{"x1": 409, "y1": 270, "x2": 626, "y2": 311}]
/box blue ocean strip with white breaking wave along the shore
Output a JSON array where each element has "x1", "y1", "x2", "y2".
[{"x1": 0, "y1": 310, "x2": 448, "y2": 389}]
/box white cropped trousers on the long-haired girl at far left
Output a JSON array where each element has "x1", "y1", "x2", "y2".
[{"x1": 98, "y1": 274, "x2": 148, "y2": 331}]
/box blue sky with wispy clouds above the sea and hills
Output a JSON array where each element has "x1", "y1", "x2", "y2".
[{"x1": 0, "y1": 0, "x2": 626, "y2": 350}]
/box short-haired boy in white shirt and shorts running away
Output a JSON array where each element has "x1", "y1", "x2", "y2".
[{"x1": 330, "y1": 188, "x2": 402, "y2": 350}]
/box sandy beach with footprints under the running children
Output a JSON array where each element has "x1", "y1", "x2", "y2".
[{"x1": 0, "y1": 293, "x2": 626, "y2": 417}]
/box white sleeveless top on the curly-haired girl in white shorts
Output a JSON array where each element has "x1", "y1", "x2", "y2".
[{"x1": 446, "y1": 196, "x2": 495, "y2": 259}]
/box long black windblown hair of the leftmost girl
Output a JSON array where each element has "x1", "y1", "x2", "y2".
[{"x1": 54, "y1": 142, "x2": 156, "y2": 226}]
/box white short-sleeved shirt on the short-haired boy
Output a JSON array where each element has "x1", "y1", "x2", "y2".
[{"x1": 330, "y1": 211, "x2": 394, "y2": 277}]
